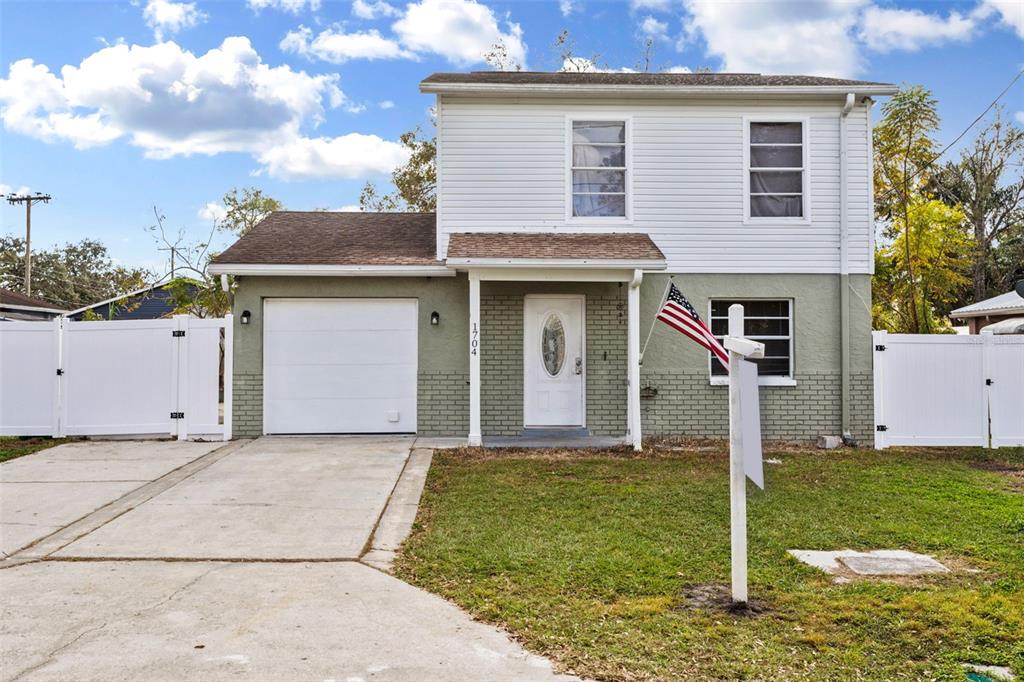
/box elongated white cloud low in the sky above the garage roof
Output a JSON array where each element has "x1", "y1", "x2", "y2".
[{"x1": 259, "y1": 133, "x2": 409, "y2": 179}]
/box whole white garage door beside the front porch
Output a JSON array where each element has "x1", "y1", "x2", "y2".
[{"x1": 263, "y1": 298, "x2": 417, "y2": 433}]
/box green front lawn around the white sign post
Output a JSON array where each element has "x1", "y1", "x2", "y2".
[{"x1": 396, "y1": 447, "x2": 1024, "y2": 680}]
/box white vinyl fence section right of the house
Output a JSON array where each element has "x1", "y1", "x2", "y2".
[{"x1": 873, "y1": 332, "x2": 1024, "y2": 449}]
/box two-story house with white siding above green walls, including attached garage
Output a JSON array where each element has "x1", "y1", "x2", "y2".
[{"x1": 211, "y1": 73, "x2": 896, "y2": 445}]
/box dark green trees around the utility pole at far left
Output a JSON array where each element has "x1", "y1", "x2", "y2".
[{"x1": 0, "y1": 235, "x2": 155, "y2": 310}]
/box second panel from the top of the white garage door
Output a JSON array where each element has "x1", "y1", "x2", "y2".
[{"x1": 266, "y1": 330, "x2": 416, "y2": 365}]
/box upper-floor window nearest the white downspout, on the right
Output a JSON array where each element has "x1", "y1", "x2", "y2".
[{"x1": 746, "y1": 121, "x2": 807, "y2": 218}]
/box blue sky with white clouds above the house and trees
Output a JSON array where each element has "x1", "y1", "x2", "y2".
[{"x1": 0, "y1": 0, "x2": 1024, "y2": 271}]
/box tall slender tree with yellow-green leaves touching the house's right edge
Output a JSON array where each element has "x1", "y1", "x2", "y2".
[{"x1": 873, "y1": 85, "x2": 939, "y2": 334}]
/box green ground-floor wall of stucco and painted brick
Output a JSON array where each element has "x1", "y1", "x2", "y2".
[{"x1": 233, "y1": 274, "x2": 873, "y2": 444}]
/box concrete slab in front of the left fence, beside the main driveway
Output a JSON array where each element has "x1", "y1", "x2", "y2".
[{"x1": 0, "y1": 440, "x2": 223, "y2": 555}]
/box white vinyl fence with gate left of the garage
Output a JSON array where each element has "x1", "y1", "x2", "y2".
[{"x1": 0, "y1": 315, "x2": 232, "y2": 440}]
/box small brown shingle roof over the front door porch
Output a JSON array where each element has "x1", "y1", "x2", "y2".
[{"x1": 447, "y1": 232, "x2": 665, "y2": 260}]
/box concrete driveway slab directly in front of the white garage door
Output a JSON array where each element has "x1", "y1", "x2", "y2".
[{"x1": 56, "y1": 436, "x2": 413, "y2": 559}]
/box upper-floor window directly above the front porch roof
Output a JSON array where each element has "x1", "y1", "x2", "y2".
[{"x1": 571, "y1": 120, "x2": 628, "y2": 218}]
